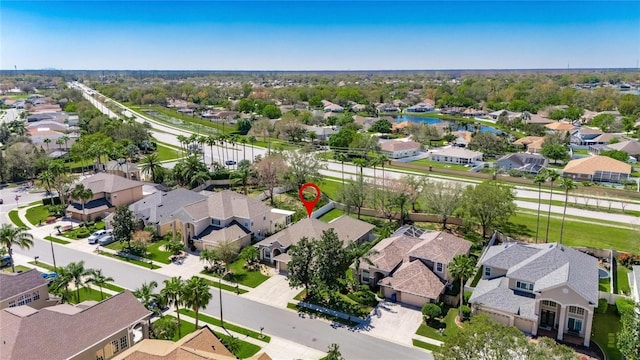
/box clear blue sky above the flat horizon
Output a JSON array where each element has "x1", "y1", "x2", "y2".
[{"x1": 0, "y1": 0, "x2": 640, "y2": 70}]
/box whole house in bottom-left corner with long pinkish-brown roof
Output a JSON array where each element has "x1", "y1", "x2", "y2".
[{"x1": 0, "y1": 291, "x2": 151, "y2": 360}]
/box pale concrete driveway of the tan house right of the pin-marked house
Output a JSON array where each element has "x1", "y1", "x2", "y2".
[{"x1": 359, "y1": 301, "x2": 422, "y2": 346}]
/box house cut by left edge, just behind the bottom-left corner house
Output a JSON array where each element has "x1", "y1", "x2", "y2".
[{"x1": 0, "y1": 269, "x2": 58, "y2": 309}]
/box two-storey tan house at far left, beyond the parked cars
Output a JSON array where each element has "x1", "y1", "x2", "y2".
[{"x1": 67, "y1": 173, "x2": 143, "y2": 221}]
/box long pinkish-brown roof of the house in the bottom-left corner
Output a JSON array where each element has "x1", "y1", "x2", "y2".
[{"x1": 0, "y1": 291, "x2": 151, "y2": 360}]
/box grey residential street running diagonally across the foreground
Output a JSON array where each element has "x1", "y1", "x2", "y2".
[{"x1": 15, "y1": 239, "x2": 433, "y2": 360}]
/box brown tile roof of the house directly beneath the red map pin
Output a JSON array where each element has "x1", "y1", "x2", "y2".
[{"x1": 258, "y1": 215, "x2": 374, "y2": 248}]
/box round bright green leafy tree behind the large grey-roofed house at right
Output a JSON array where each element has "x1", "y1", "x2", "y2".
[{"x1": 461, "y1": 180, "x2": 516, "y2": 238}]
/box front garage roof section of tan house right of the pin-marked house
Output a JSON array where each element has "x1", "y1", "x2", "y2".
[{"x1": 380, "y1": 260, "x2": 445, "y2": 299}]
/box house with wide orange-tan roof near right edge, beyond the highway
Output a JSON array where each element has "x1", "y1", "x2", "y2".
[{"x1": 563, "y1": 155, "x2": 631, "y2": 183}]
